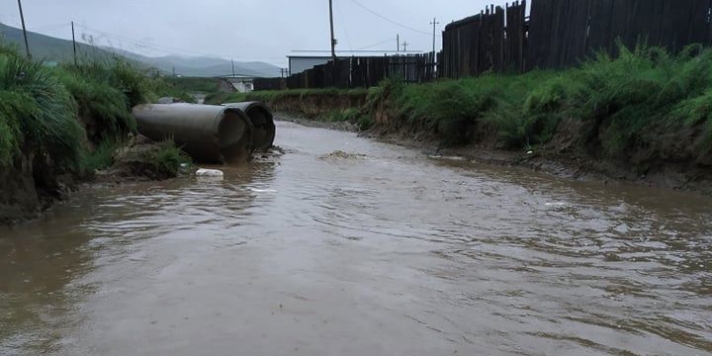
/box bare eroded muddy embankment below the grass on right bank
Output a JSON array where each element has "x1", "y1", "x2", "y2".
[{"x1": 256, "y1": 93, "x2": 712, "y2": 196}]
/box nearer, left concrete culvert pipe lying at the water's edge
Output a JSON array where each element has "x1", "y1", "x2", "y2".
[{"x1": 133, "y1": 104, "x2": 255, "y2": 164}]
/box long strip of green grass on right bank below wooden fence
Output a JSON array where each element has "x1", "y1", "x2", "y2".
[{"x1": 203, "y1": 41, "x2": 712, "y2": 161}]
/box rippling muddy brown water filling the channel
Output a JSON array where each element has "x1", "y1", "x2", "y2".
[{"x1": 0, "y1": 123, "x2": 712, "y2": 356}]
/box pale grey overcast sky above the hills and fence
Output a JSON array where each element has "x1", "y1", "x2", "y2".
[{"x1": 0, "y1": 0, "x2": 512, "y2": 67}]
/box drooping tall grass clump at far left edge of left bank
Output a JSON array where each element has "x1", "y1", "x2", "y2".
[{"x1": 0, "y1": 51, "x2": 84, "y2": 169}]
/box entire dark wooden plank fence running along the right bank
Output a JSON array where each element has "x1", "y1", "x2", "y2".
[{"x1": 255, "y1": 0, "x2": 712, "y2": 90}]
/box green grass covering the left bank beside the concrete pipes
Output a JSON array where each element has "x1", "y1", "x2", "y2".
[{"x1": 0, "y1": 44, "x2": 195, "y2": 179}]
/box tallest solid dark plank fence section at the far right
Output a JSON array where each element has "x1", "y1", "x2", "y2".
[{"x1": 526, "y1": 0, "x2": 712, "y2": 69}]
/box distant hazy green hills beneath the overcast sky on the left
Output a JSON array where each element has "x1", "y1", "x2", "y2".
[{"x1": 0, "y1": 24, "x2": 280, "y2": 77}]
